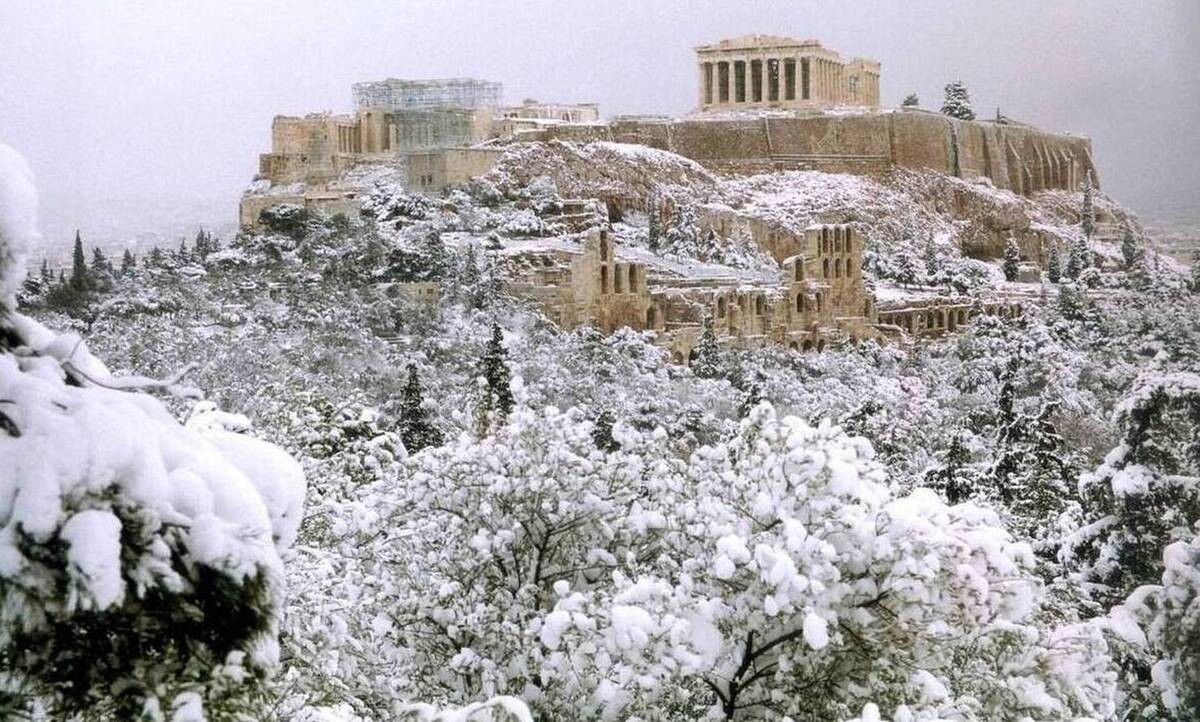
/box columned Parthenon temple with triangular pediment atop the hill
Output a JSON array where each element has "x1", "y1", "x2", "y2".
[{"x1": 696, "y1": 35, "x2": 880, "y2": 110}]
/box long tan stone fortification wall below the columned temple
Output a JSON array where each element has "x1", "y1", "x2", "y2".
[{"x1": 538, "y1": 110, "x2": 1099, "y2": 194}]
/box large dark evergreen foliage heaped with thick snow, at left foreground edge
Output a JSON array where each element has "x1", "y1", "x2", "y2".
[{"x1": 0, "y1": 146, "x2": 305, "y2": 721}]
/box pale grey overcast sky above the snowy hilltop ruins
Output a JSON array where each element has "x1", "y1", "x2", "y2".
[{"x1": 0, "y1": 0, "x2": 1200, "y2": 251}]
